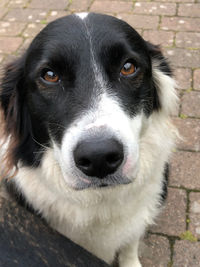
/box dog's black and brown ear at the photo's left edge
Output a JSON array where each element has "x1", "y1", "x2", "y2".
[{"x1": 0, "y1": 56, "x2": 31, "y2": 177}]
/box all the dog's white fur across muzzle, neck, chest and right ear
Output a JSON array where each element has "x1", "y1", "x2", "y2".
[{"x1": 12, "y1": 67, "x2": 176, "y2": 267}]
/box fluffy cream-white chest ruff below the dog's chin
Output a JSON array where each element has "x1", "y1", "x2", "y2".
[{"x1": 15, "y1": 170, "x2": 161, "y2": 263}]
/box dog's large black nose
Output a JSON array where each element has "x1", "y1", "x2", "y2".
[{"x1": 74, "y1": 137, "x2": 124, "y2": 178}]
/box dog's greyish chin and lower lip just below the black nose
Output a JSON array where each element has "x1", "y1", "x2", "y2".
[{"x1": 65, "y1": 175, "x2": 132, "y2": 191}]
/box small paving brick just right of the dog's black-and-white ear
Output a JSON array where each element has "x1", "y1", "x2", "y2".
[{"x1": 174, "y1": 68, "x2": 192, "y2": 89}]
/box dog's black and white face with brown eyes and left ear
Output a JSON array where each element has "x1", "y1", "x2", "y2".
[{"x1": 1, "y1": 14, "x2": 172, "y2": 189}]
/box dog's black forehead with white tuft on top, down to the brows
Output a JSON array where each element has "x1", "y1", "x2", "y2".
[{"x1": 26, "y1": 13, "x2": 149, "y2": 78}]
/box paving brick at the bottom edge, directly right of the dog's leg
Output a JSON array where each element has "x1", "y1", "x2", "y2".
[{"x1": 139, "y1": 234, "x2": 170, "y2": 267}]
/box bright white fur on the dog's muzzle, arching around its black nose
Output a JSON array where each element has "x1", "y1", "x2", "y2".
[{"x1": 54, "y1": 93, "x2": 143, "y2": 188}]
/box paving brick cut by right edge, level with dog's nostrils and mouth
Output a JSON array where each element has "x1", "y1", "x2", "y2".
[{"x1": 169, "y1": 151, "x2": 200, "y2": 189}]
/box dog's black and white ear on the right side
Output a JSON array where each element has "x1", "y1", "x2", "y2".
[{"x1": 146, "y1": 42, "x2": 178, "y2": 115}]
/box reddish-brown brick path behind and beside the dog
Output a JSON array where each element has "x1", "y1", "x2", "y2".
[{"x1": 0, "y1": 0, "x2": 200, "y2": 267}]
